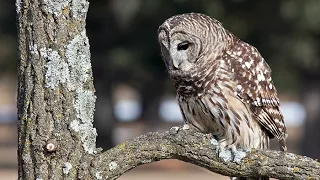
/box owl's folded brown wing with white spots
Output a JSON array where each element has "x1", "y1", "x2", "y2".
[{"x1": 226, "y1": 40, "x2": 286, "y2": 149}]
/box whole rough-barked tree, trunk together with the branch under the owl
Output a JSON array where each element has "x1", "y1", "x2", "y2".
[{"x1": 16, "y1": 0, "x2": 320, "y2": 180}]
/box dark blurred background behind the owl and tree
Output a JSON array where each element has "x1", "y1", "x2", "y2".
[{"x1": 0, "y1": 0, "x2": 320, "y2": 180}]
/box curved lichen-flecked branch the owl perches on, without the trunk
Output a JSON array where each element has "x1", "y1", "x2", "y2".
[{"x1": 86, "y1": 129, "x2": 320, "y2": 179}]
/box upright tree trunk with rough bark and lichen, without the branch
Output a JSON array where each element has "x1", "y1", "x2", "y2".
[{"x1": 16, "y1": 0, "x2": 97, "y2": 179}]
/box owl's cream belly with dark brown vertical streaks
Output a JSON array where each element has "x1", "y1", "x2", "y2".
[{"x1": 178, "y1": 87, "x2": 268, "y2": 148}]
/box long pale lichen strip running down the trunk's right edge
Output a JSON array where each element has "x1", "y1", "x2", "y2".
[{"x1": 65, "y1": 31, "x2": 97, "y2": 154}]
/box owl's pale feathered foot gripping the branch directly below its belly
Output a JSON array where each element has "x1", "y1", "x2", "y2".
[{"x1": 211, "y1": 138, "x2": 249, "y2": 164}]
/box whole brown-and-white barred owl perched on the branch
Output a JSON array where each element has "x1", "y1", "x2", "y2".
[{"x1": 158, "y1": 13, "x2": 286, "y2": 179}]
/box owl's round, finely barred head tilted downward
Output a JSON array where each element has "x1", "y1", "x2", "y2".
[{"x1": 158, "y1": 13, "x2": 228, "y2": 74}]
